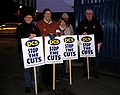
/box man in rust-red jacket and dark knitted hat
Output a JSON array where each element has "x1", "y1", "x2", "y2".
[{"x1": 37, "y1": 8, "x2": 58, "y2": 86}]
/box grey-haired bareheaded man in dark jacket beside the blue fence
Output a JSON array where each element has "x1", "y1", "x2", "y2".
[{"x1": 77, "y1": 9, "x2": 103, "y2": 78}]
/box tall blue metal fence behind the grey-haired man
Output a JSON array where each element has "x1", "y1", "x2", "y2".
[{"x1": 74, "y1": 0, "x2": 120, "y2": 71}]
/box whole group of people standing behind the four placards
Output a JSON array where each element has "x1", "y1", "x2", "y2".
[{"x1": 16, "y1": 8, "x2": 102, "y2": 93}]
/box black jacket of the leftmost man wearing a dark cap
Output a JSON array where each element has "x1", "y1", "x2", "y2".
[{"x1": 15, "y1": 22, "x2": 41, "y2": 53}]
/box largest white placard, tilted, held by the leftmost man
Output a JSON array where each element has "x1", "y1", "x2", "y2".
[{"x1": 21, "y1": 37, "x2": 44, "y2": 68}]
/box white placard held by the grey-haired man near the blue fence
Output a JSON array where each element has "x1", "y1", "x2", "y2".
[{"x1": 79, "y1": 34, "x2": 96, "y2": 57}]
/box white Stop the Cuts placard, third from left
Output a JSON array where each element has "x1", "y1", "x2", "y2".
[{"x1": 61, "y1": 35, "x2": 78, "y2": 60}]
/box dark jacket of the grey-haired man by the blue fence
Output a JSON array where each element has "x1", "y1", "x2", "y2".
[{"x1": 77, "y1": 18, "x2": 103, "y2": 44}]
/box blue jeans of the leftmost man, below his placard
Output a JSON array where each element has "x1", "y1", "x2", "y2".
[{"x1": 19, "y1": 54, "x2": 42, "y2": 88}]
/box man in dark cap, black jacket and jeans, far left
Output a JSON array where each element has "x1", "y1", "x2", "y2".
[{"x1": 15, "y1": 12, "x2": 41, "y2": 93}]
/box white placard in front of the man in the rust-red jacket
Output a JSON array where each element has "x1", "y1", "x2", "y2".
[{"x1": 45, "y1": 36, "x2": 63, "y2": 64}]
